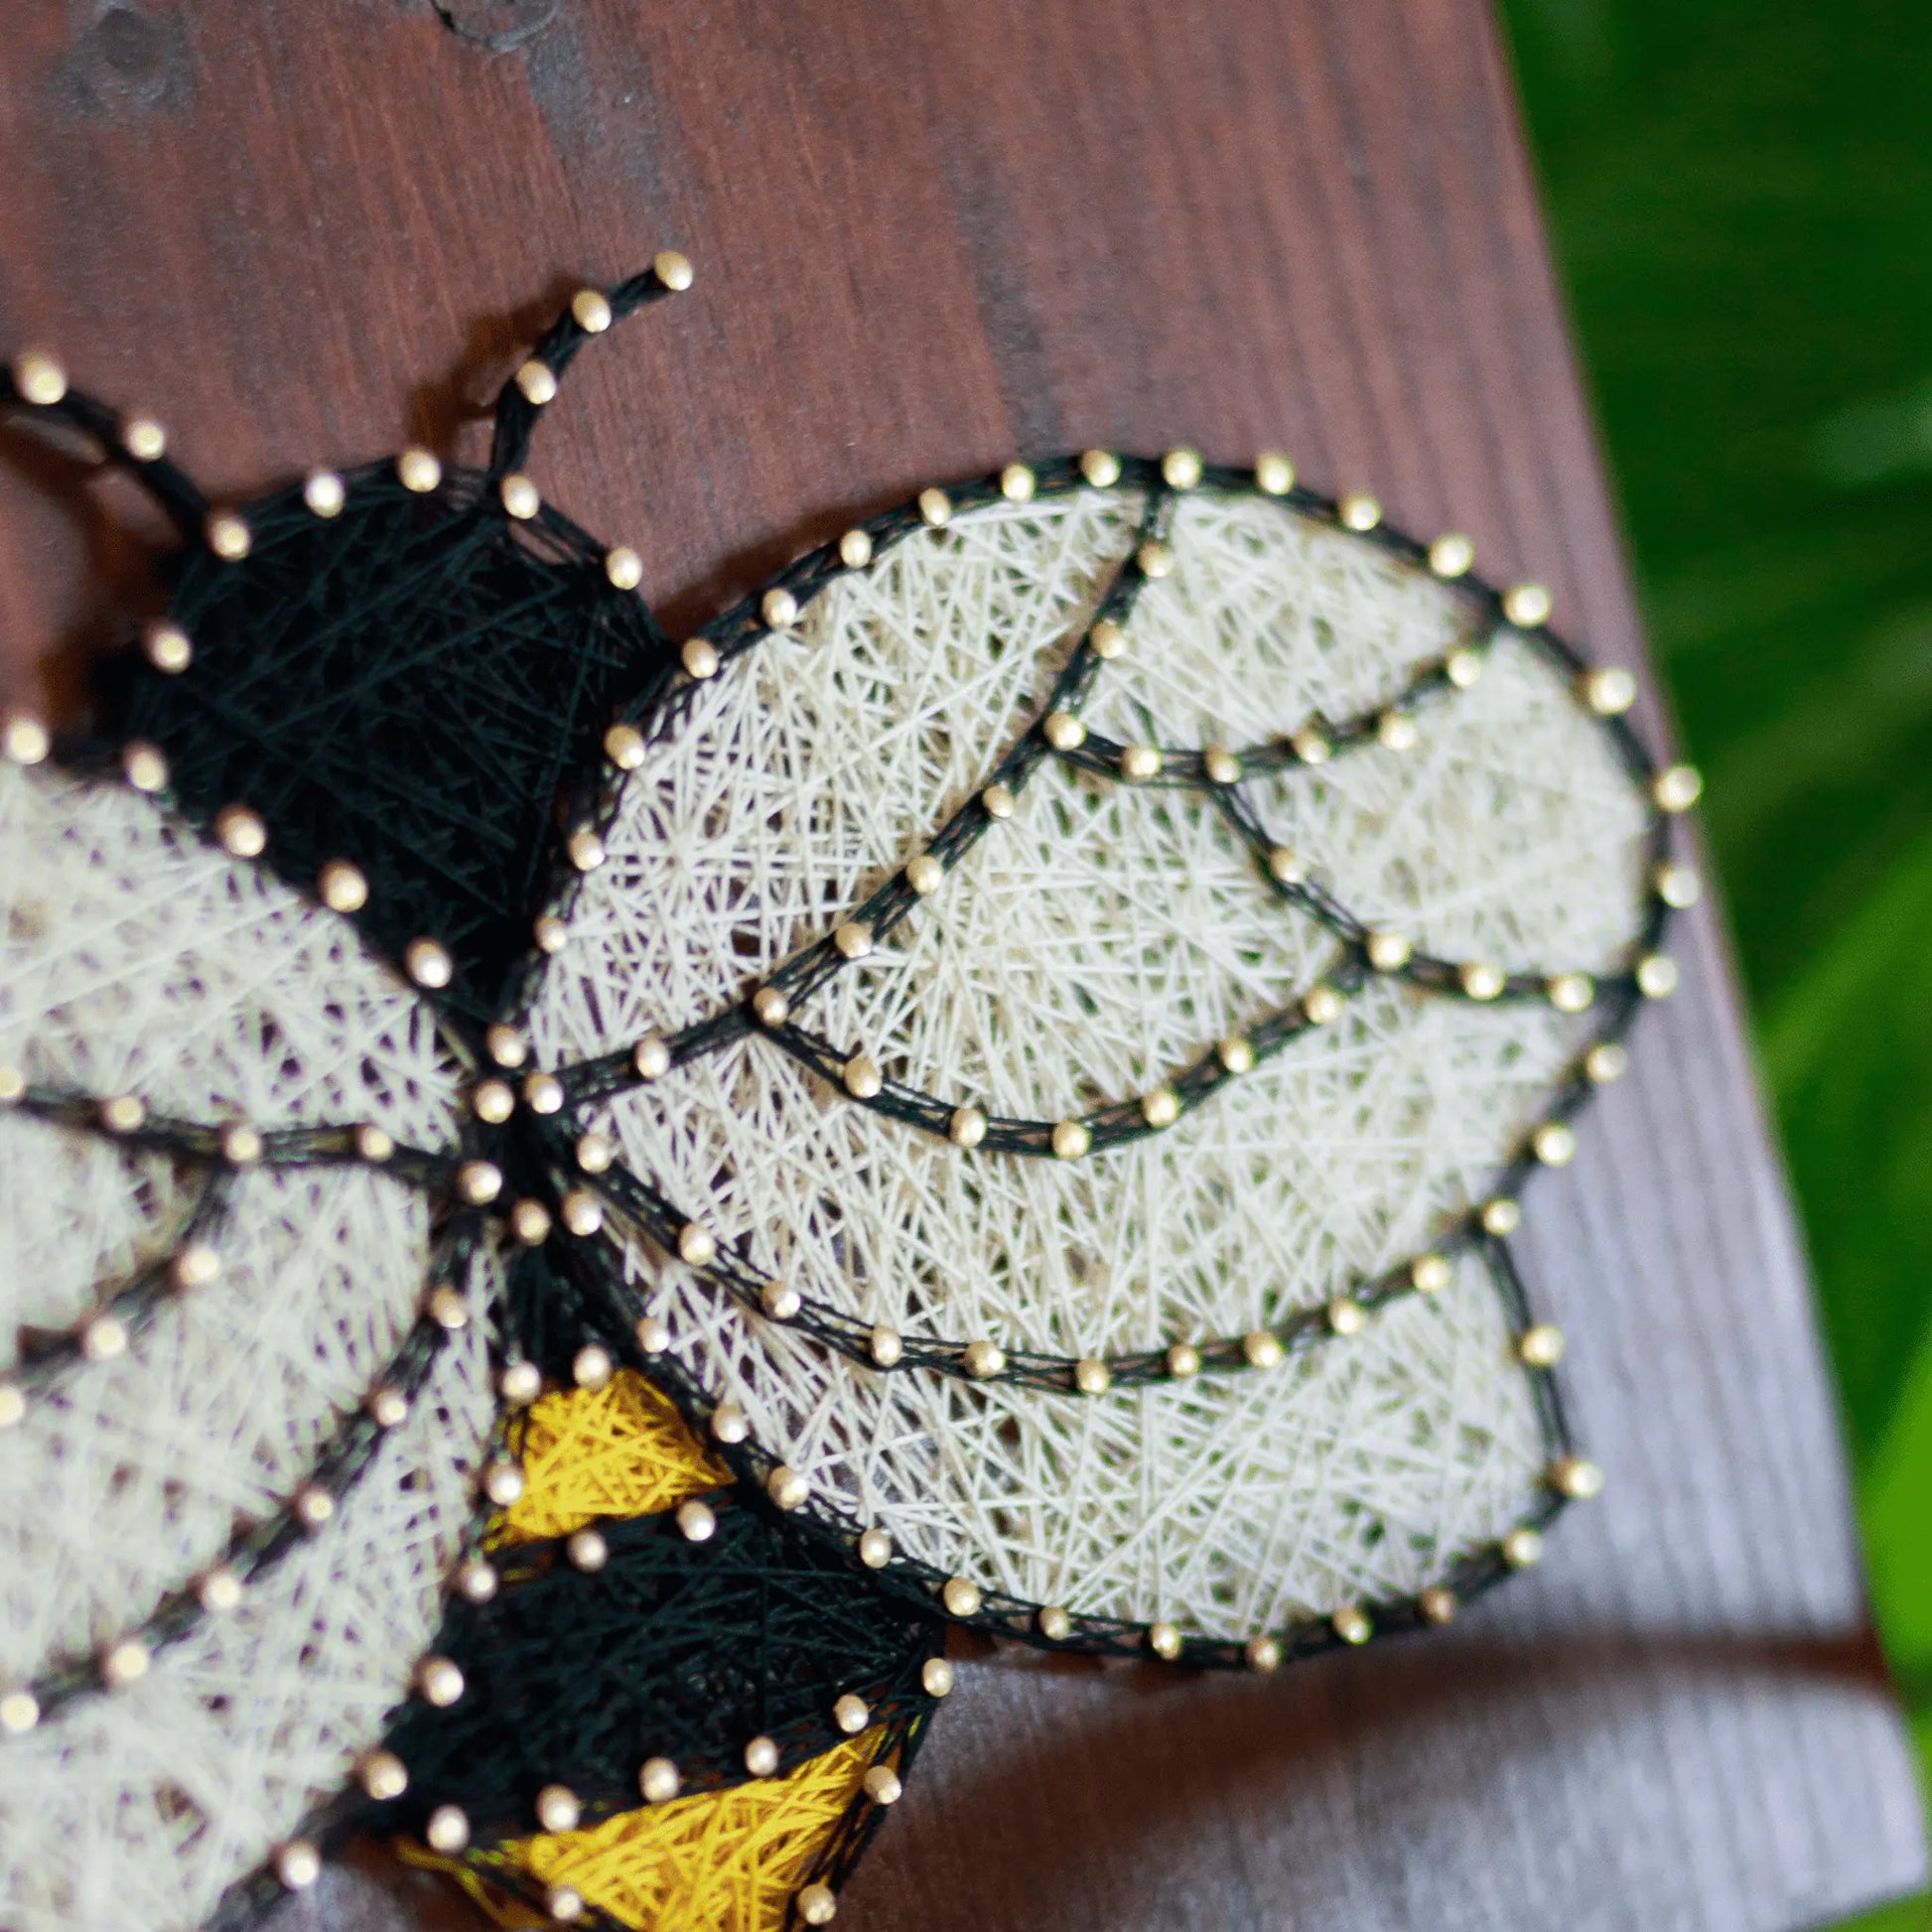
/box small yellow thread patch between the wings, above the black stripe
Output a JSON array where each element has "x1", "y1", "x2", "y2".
[{"x1": 488, "y1": 1368, "x2": 731, "y2": 1548}]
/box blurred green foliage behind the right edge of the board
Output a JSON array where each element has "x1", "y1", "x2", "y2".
[{"x1": 1503, "y1": 0, "x2": 1932, "y2": 1932}]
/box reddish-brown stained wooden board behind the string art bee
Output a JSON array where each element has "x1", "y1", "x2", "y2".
[{"x1": 0, "y1": 0, "x2": 1924, "y2": 1932}]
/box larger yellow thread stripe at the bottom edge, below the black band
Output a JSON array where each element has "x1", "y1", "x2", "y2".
[{"x1": 483, "y1": 1727, "x2": 887, "y2": 1932}]
